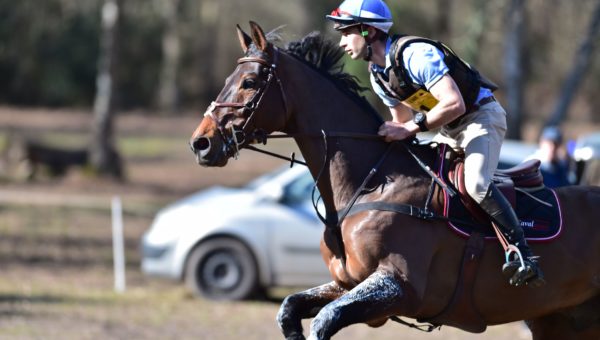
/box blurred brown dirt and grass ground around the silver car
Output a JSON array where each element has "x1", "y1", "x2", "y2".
[{"x1": 0, "y1": 108, "x2": 530, "y2": 340}]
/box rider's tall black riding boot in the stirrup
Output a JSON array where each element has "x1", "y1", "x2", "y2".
[{"x1": 480, "y1": 183, "x2": 545, "y2": 287}]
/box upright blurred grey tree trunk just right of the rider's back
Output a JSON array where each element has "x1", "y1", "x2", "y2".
[{"x1": 504, "y1": 0, "x2": 526, "y2": 139}]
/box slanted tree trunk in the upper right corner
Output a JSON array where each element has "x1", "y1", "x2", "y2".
[{"x1": 546, "y1": 1, "x2": 600, "y2": 125}]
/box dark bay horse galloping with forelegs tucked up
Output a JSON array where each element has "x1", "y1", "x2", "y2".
[{"x1": 190, "y1": 22, "x2": 600, "y2": 340}]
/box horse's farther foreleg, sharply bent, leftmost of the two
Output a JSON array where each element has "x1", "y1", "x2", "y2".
[{"x1": 277, "y1": 282, "x2": 346, "y2": 340}]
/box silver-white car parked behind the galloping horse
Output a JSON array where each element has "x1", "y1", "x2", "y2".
[{"x1": 142, "y1": 141, "x2": 535, "y2": 300}]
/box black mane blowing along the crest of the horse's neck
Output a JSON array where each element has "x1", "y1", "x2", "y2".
[{"x1": 266, "y1": 29, "x2": 382, "y2": 121}]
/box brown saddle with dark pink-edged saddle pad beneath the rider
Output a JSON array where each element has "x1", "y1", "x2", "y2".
[{"x1": 438, "y1": 145, "x2": 562, "y2": 242}]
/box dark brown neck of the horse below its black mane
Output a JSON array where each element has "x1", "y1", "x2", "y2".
[{"x1": 278, "y1": 58, "x2": 400, "y2": 210}]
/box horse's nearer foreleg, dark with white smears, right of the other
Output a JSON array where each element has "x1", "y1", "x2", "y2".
[{"x1": 309, "y1": 271, "x2": 402, "y2": 340}]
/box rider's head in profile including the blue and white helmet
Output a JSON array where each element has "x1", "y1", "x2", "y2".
[{"x1": 326, "y1": 0, "x2": 393, "y2": 60}]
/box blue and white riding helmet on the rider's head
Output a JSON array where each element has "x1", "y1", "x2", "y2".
[{"x1": 325, "y1": 0, "x2": 393, "y2": 33}]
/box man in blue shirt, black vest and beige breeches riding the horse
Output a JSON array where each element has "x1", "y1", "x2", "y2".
[{"x1": 326, "y1": 0, "x2": 544, "y2": 286}]
